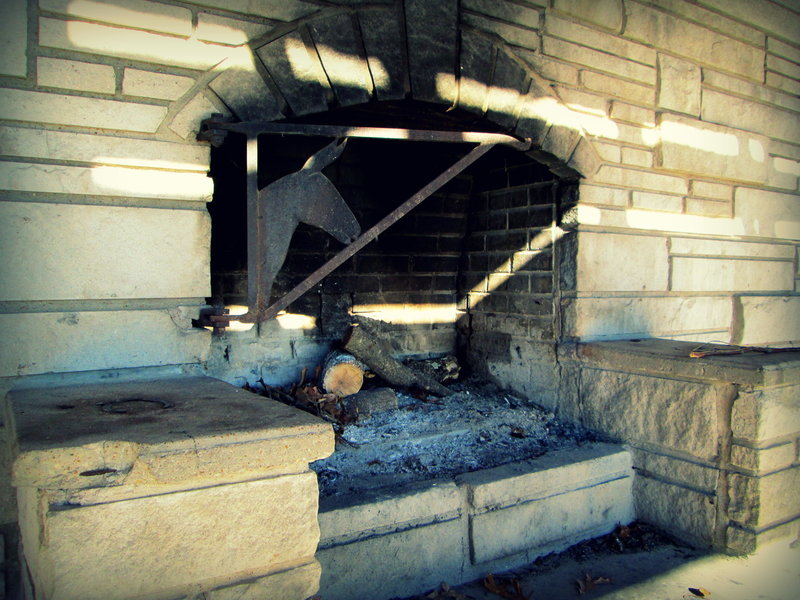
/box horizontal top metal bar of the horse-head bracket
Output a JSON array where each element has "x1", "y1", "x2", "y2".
[{"x1": 203, "y1": 119, "x2": 530, "y2": 150}]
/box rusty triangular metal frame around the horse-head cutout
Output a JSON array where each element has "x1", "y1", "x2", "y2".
[{"x1": 197, "y1": 115, "x2": 531, "y2": 331}]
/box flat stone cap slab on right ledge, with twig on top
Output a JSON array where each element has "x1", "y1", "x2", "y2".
[{"x1": 565, "y1": 338, "x2": 800, "y2": 387}]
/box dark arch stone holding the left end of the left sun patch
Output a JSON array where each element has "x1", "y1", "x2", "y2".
[{"x1": 256, "y1": 31, "x2": 329, "y2": 115}]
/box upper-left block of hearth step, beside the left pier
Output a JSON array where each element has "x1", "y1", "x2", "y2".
[{"x1": 319, "y1": 481, "x2": 461, "y2": 548}]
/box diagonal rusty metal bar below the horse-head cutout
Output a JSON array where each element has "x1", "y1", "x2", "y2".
[{"x1": 251, "y1": 143, "x2": 494, "y2": 322}]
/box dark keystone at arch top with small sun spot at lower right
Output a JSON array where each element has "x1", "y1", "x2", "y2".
[{"x1": 405, "y1": 0, "x2": 458, "y2": 104}]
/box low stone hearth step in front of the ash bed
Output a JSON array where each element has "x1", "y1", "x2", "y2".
[{"x1": 317, "y1": 443, "x2": 634, "y2": 600}]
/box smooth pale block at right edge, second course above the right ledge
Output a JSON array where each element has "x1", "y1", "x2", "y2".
[{"x1": 672, "y1": 257, "x2": 794, "y2": 292}]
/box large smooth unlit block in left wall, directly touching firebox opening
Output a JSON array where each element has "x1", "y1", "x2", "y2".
[{"x1": 0, "y1": 204, "x2": 210, "y2": 301}]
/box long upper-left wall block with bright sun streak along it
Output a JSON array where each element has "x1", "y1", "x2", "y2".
[{"x1": 39, "y1": 17, "x2": 232, "y2": 69}]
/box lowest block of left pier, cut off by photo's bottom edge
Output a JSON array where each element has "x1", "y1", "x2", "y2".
[{"x1": 203, "y1": 560, "x2": 322, "y2": 600}]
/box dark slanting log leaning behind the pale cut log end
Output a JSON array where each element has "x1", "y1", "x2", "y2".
[{"x1": 342, "y1": 325, "x2": 452, "y2": 396}]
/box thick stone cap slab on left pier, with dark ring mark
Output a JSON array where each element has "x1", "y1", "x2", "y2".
[{"x1": 8, "y1": 376, "x2": 334, "y2": 489}]
